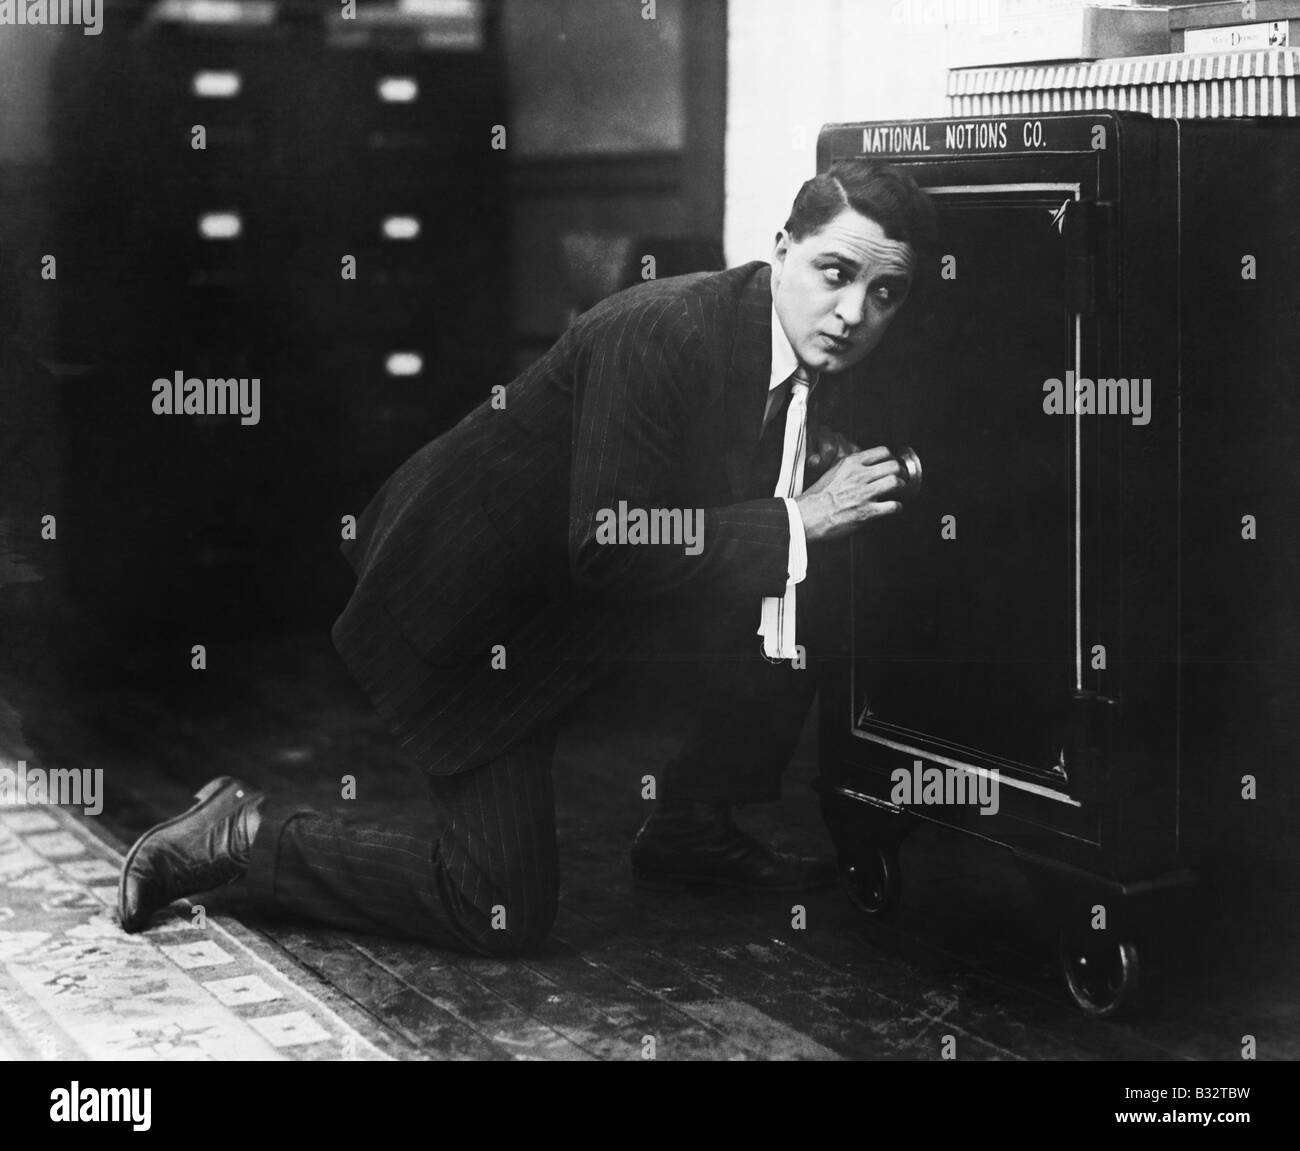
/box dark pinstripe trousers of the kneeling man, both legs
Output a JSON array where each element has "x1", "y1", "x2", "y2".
[{"x1": 247, "y1": 555, "x2": 847, "y2": 957}]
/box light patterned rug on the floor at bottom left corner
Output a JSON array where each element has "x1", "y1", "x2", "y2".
[{"x1": 0, "y1": 805, "x2": 390, "y2": 1060}]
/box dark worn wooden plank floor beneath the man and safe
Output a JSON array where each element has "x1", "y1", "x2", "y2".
[{"x1": 0, "y1": 624, "x2": 1300, "y2": 1060}]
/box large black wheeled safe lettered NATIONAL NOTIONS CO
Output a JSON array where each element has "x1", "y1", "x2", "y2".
[{"x1": 818, "y1": 111, "x2": 1300, "y2": 1016}]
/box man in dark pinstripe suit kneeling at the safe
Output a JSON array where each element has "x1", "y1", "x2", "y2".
[{"x1": 120, "y1": 161, "x2": 933, "y2": 955}]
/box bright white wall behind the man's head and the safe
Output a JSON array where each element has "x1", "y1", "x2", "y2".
[{"x1": 724, "y1": 0, "x2": 948, "y2": 265}]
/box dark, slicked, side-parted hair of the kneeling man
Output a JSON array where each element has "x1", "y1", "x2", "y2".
[{"x1": 785, "y1": 160, "x2": 939, "y2": 256}]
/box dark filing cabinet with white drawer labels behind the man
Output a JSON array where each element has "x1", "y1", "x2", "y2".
[{"x1": 47, "y1": 0, "x2": 510, "y2": 642}]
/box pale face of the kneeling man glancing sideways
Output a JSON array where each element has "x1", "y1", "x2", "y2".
[{"x1": 772, "y1": 208, "x2": 917, "y2": 372}]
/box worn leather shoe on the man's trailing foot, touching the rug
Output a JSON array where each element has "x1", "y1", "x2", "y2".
[{"x1": 117, "y1": 775, "x2": 263, "y2": 933}]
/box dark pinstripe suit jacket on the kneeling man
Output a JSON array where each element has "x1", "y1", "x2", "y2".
[{"x1": 333, "y1": 263, "x2": 857, "y2": 774}]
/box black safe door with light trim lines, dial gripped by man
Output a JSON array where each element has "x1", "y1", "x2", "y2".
[{"x1": 820, "y1": 124, "x2": 1118, "y2": 864}]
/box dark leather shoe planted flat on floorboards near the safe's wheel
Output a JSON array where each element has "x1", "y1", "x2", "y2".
[{"x1": 632, "y1": 804, "x2": 839, "y2": 891}]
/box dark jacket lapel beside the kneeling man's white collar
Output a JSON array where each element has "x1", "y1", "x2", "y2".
[{"x1": 725, "y1": 264, "x2": 772, "y2": 499}]
